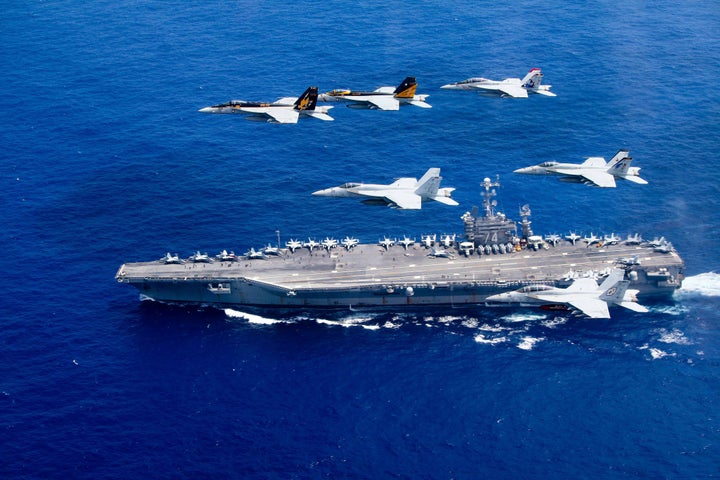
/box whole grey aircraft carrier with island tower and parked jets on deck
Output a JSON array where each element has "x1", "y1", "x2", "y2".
[{"x1": 116, "y1": 178, "x2": 685, "y2": 308}]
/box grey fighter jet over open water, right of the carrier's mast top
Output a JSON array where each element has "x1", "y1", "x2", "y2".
[{"x1": 515, "y1": 150, "x2": 647, "y2": 188}]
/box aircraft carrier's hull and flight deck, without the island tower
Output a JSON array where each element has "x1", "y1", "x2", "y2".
[{"x1": 117, "y1": 242, "x2": 684, "y2": 308}]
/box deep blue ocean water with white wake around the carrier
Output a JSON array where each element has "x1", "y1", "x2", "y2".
[{"x1": 0, "y1": 0, "x2": 720, "y2": 479}]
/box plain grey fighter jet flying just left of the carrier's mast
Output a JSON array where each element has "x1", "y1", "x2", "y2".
[{"x1": 313, "y1": 168, "x2": 458, "y2": 210}]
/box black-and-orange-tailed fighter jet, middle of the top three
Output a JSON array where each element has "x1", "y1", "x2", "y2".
[{"x1": 318, "y1": 77, "x2": 432, "y2": 110}]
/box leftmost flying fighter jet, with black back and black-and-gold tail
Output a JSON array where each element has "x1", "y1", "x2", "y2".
[{"x1": 198, "y1": 87, "x2": 334, "y2": 123}]
